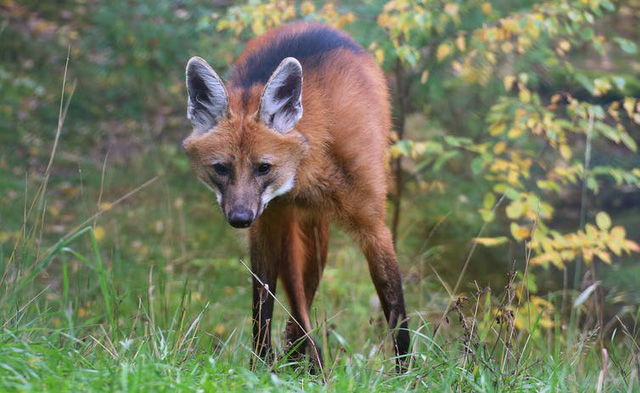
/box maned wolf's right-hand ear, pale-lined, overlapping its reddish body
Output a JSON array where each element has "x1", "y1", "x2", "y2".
[{"x1": 260, "y1": 57, "x2": 302, "y2": 134}]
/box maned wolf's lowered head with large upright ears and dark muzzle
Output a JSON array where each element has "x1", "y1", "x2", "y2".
[{"x1": 183, "y1": 57, "x2": 307, "y2": 228}]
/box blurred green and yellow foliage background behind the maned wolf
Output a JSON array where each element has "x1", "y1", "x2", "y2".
[{"x1": 0, "y1": 0, "x2": 640, "y2": 360}]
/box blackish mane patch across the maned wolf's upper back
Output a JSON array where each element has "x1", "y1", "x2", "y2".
[{"x1": 229, "y1": 24, "x2": 363, "y2": 89}]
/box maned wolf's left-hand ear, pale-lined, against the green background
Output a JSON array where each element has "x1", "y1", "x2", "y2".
[{"x1": 187, "y1": 57, "x2": 229, "y2": 132}]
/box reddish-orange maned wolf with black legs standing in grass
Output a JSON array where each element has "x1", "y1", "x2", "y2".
[{"x1": 184, "y1": 23, "x2": 409, "y2": 370}]
